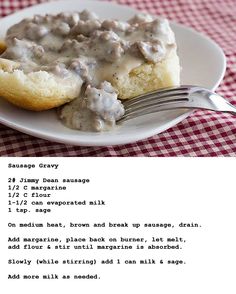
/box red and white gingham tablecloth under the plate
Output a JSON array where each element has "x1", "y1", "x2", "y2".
[{"x1": 0, "y1": 0, "x2": 236, "y2": 157}]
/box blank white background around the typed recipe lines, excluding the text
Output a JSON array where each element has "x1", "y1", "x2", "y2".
[{"x1": 0, "y1": 158, "x2": 236, "y2": 294}]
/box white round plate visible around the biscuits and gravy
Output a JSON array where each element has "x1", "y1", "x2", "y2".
[{"x1": 0, "y1": 0, "x2": 226, "y2": 146}]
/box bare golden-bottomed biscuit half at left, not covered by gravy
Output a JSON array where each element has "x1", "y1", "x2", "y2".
[{"x1": 0, "y1": 59, "x2": 82, "y2": 111}]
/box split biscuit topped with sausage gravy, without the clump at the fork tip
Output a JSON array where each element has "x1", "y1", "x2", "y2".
[{"x1": 0, "y1": 11, "x2": 180, "y2": 119}]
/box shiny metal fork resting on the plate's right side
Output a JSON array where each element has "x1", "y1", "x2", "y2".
[{"x1": 118, "y1": 86, "x2": 236, "y2": 122}]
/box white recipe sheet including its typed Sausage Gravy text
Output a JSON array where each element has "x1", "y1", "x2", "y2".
[{"x1": 0, "y1": 158, "x2": 236, "y2": 294}]
